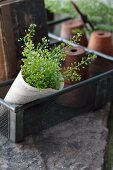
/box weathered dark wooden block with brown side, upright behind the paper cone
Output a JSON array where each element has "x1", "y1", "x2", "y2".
[{"x1": 0, "y1": 0, "x2": 48, "y2": 96}]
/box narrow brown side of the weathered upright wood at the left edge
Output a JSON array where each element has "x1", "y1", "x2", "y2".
[{"x1": 0, "y1": 6, "x2": 17, "y2": 80}]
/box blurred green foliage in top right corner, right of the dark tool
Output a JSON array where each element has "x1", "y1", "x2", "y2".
[{"x1": 77, "y1": 0, "x2": 113, "y2": 31}]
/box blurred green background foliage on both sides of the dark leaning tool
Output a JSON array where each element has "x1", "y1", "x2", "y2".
[{"x1": 45, "y1": 0, "x2": 113, "y2": 31}]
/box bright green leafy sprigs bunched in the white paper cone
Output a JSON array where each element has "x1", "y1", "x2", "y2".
[{"x1": 20, "y1": 24, "x2": 96, "y2": 89}]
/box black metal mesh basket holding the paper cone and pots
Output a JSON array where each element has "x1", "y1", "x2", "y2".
[{"x1": 0, "y1": 34, "x2": 113, "y2": 142}]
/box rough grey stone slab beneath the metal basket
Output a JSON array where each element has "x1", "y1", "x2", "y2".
[{"x1": 0, "y1": 104, "x2": 109, "y2": 170}]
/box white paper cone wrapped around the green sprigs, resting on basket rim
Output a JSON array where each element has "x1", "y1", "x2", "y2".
[{"x1": 4, "y1": 71, "x2": 64, "y2": 104}]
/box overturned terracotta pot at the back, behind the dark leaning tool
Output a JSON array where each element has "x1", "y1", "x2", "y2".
[{"x1": 60, "y1": 20, "x2": 88, "y2": 46}]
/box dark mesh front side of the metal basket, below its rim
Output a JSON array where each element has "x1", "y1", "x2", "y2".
[{"x1": 24, "y1": 71, "x2": 113, "y2": 136}]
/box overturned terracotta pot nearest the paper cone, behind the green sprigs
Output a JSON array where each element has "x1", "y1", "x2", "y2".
[{"x1": 57, "y1": 47, "x2": 93, "y2": 108}]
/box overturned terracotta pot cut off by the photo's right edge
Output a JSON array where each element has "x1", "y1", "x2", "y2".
[{"x1": 88, "y1": 31, "x2": 113, "y2": 77}]
